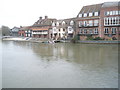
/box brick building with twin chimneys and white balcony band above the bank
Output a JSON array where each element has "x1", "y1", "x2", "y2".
[{"x1": 31, "y1": 16, "x2": 56, "y2": 38}]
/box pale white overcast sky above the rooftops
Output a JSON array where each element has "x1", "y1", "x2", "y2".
[{"x1": 0, "y1": 0, "x2": 117, "y2": 28}]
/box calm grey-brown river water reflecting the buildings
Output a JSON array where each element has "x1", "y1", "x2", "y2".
[{"x1": 1, "y1": 41, "x2": 118, "y2": 88}]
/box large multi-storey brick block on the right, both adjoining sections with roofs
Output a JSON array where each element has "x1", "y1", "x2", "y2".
[{"x1": 76, "y1": 2, "x2": 120, "y2": 40}]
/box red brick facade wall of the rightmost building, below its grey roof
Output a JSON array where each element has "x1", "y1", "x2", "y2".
[{"x1": 99, "y1": 6, "x2": 120, "y2": 40}]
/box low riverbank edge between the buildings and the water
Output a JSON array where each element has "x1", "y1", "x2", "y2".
[{"x1": 2, "y1": 37, "x2": 120, "y2": 44}]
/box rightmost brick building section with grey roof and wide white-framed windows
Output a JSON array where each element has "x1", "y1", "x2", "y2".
[{"x1": 99, "y1": 2, "x2": 120, "y2": 39}]
